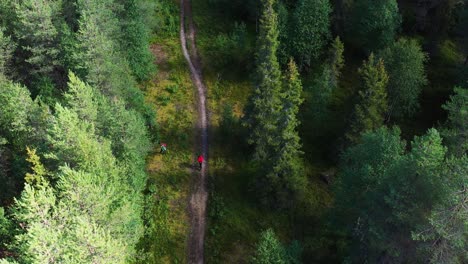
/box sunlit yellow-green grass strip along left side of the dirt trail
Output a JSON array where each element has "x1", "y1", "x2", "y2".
[{"x1": 144, "y1": 1, "x2": 197, "y2": 263}]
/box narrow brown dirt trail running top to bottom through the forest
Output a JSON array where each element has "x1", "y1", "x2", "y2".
[{"x1": 180, "y1": 0, "x2": 208, "y2": 264}]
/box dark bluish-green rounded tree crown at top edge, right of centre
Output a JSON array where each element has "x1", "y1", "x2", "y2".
[{"x1": 345, "y1": 0, "x2": 401, "y2": 53}]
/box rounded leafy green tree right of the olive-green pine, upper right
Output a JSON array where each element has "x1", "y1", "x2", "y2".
[{"x1": 379, "y1": 39, "x2": 428, "y2": 118}]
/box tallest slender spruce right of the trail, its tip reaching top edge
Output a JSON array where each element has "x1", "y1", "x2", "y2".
[{"x1": 246, "y1": 0, "x2": 282, "y2": 162}]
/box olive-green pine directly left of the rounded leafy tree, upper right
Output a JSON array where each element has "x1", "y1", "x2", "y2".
[{"x1": 346, "y1": 54, "x2": 388, "y2": 143}]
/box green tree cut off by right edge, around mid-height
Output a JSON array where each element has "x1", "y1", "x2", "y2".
[{"x1": 442, "y1": 87, "x2": 468, "y2": 156}]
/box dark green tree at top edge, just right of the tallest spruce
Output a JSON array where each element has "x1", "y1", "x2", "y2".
[{"x1": 288, "y1": 0, "x2": 332, "y2": 67}]
